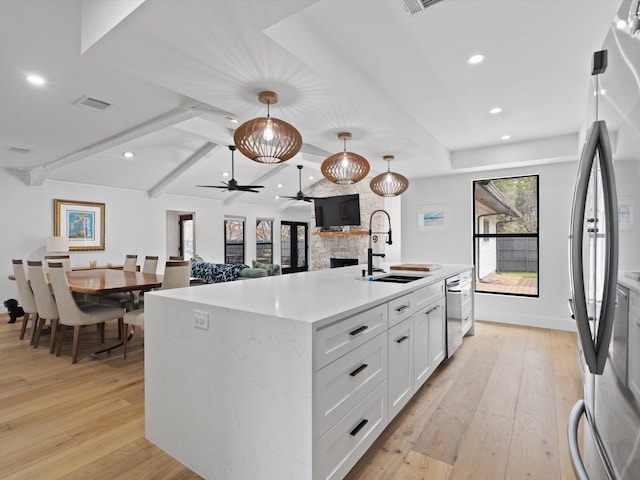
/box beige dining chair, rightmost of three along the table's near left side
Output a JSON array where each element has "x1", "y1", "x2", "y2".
[{"x1": 49, "y1": 263, "x2": 124, "y2": 363}]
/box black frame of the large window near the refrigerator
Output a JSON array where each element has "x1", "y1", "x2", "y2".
[{"x1": 471, "y1": 174, "x2": 540, "y2": 298}]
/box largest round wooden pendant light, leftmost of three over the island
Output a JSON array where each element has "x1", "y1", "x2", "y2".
[{"x1": 233, "y1": 92, "x2": 302, "y2": 163}]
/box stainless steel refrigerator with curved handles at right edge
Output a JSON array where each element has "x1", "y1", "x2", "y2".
[{"x1": 568, "y1": 0, "x2": 640, "y2": 480}]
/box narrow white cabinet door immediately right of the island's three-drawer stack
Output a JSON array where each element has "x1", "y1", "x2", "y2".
[{"x1": 388, "y1": 317, "x2": 414, "y2": 419}]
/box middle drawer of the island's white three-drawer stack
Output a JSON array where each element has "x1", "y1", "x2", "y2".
[{"x1": 314, "y1": 334, "x2": 387, "y2": 438}]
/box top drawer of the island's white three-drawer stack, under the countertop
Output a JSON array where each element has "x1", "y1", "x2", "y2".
[{"x1": 313, "y1": 304, "x2": 388, "y2": 370}]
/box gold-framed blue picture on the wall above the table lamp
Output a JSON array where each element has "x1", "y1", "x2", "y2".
[{"x1": 53, "y1": 199, "x2": 104, "y2": 250}]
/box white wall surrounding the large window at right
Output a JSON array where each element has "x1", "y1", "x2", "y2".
[{"x1": 402, "y1": 162, "x2": 577, "y2": 330}]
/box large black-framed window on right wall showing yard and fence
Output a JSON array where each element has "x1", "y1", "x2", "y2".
[{"x1": 473, "y1": 175, "x2": 539, "y2": 297}]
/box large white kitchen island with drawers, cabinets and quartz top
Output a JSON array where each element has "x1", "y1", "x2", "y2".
[{"x1": 145, "y1": 265, "x2": 472, "y2": 480}]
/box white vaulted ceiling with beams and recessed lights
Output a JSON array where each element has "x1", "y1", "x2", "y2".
[{"x1": 0, "y1": 0, "x2": 619, "y2": 206}]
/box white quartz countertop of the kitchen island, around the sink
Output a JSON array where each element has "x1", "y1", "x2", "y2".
[{"x1": 145, "y1": 264, "x2": 473, "y2": 324}]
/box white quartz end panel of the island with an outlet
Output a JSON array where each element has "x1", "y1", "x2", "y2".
[{"x1": 144, "y1": 296, "x2": 313, "y2": 480}]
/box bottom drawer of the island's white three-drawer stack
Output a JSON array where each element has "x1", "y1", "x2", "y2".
[{"x1": 313, "y1": 381, "x2": 387, "y2": 480}]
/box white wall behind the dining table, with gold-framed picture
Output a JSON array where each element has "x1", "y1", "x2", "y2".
[{"x1": 0, "y1": 169, "x2": 310, "y2": 301}]
